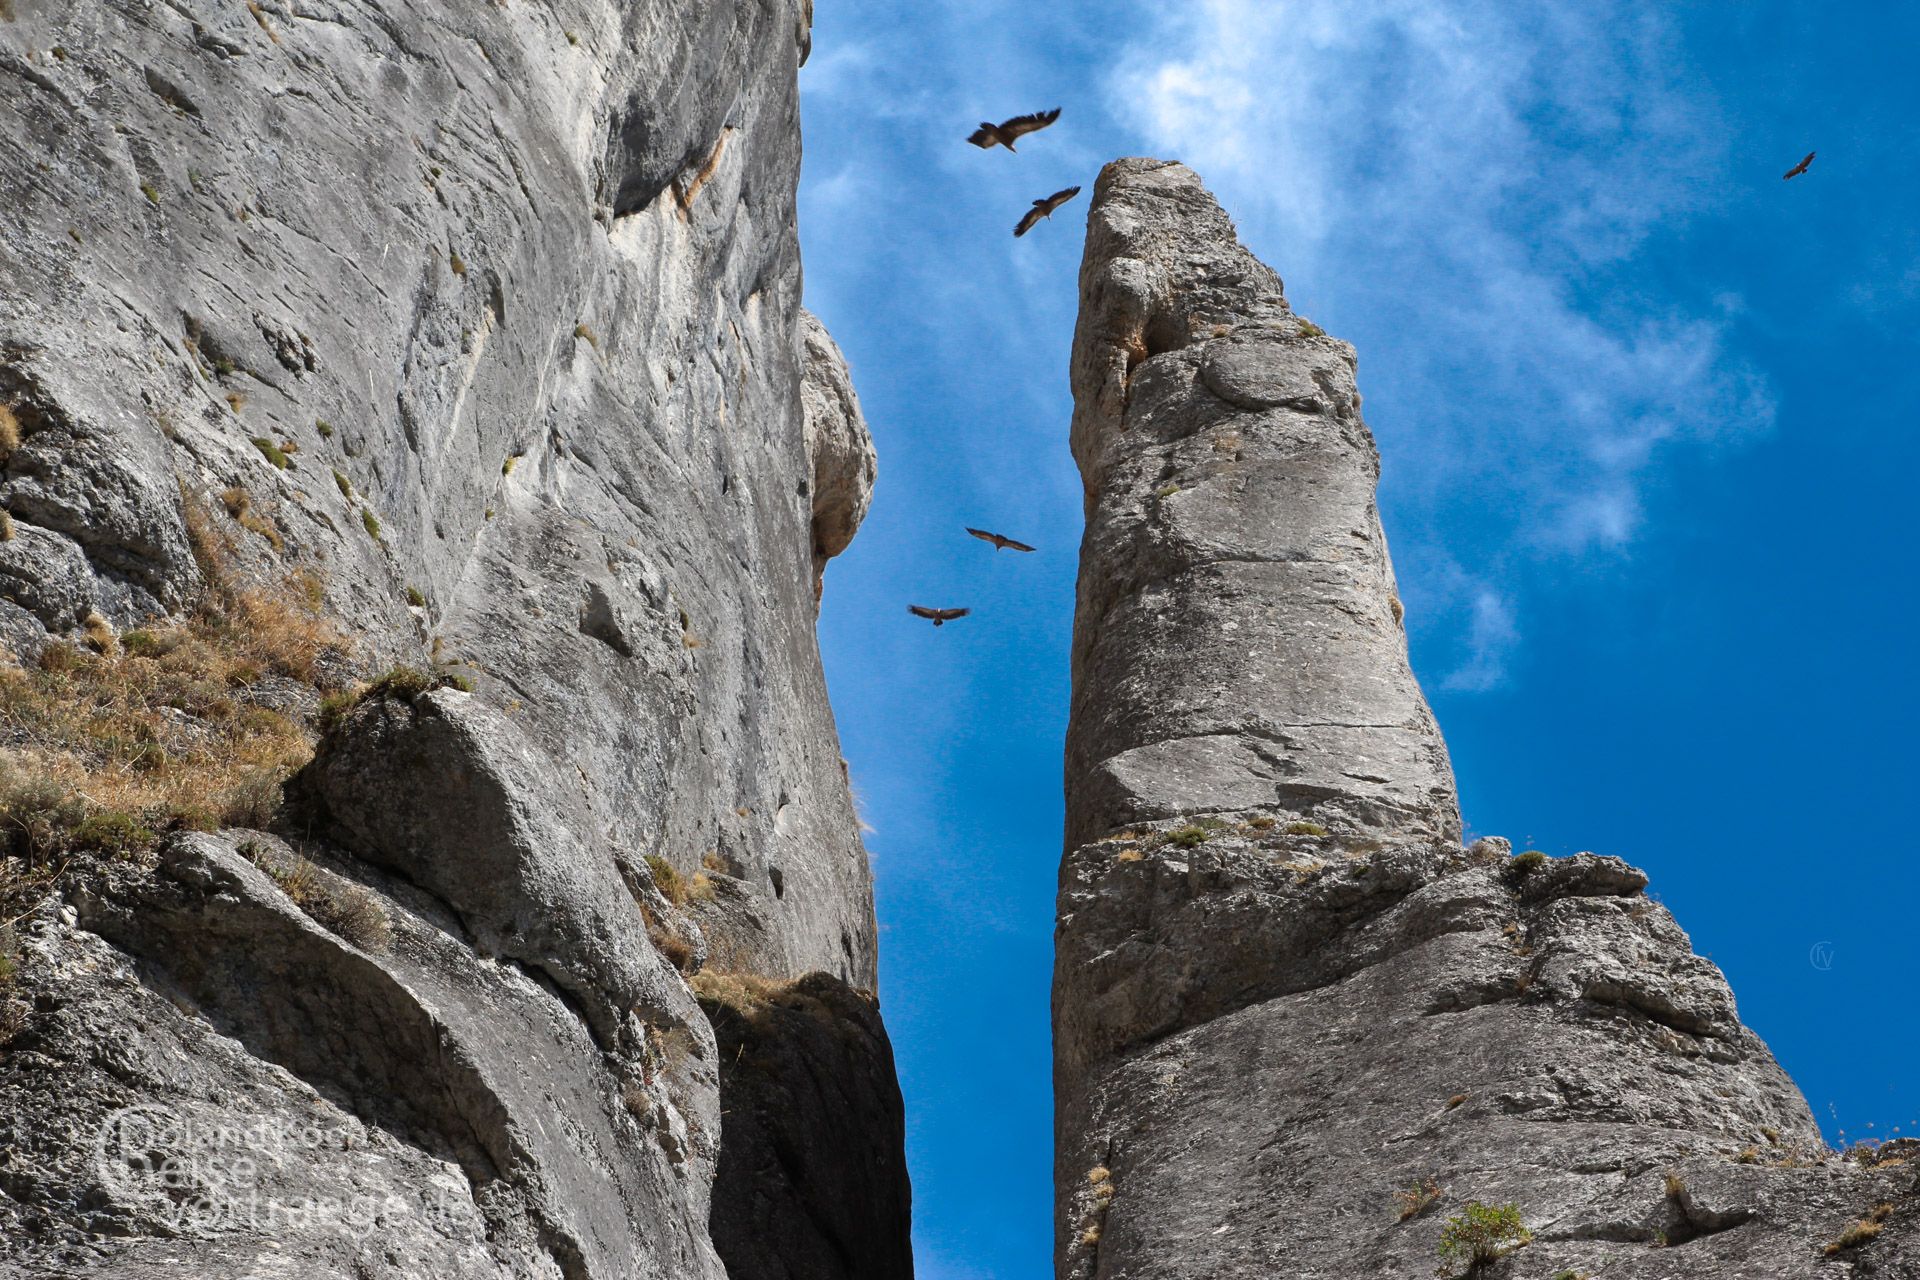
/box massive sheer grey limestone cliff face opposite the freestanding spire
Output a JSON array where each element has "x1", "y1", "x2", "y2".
[{"x1": 0, "y1": 0, "x2": 906, "y2": 1280}]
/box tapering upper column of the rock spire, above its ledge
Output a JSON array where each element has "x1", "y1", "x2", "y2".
[{"x1": 1068, "y1": 159, "x2": 1459, "y2": 844}]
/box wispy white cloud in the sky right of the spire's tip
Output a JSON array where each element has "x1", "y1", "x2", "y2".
[{"x1": 1110, "y1": 0, "x2": 1774, "y2": 689}]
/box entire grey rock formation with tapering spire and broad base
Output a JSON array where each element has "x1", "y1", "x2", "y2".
[{"x1": 1054, "y1": 159, "x2": 1920, "y2": 1280}]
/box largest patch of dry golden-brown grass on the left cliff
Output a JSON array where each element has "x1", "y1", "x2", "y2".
[{"x1": 0, "y1": 507, "x2": 346, "y2": 867}]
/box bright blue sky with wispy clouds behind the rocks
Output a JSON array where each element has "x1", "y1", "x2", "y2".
[{"x1": 801, "y1": 0, "x2": 1920, "y2": 1280}]
